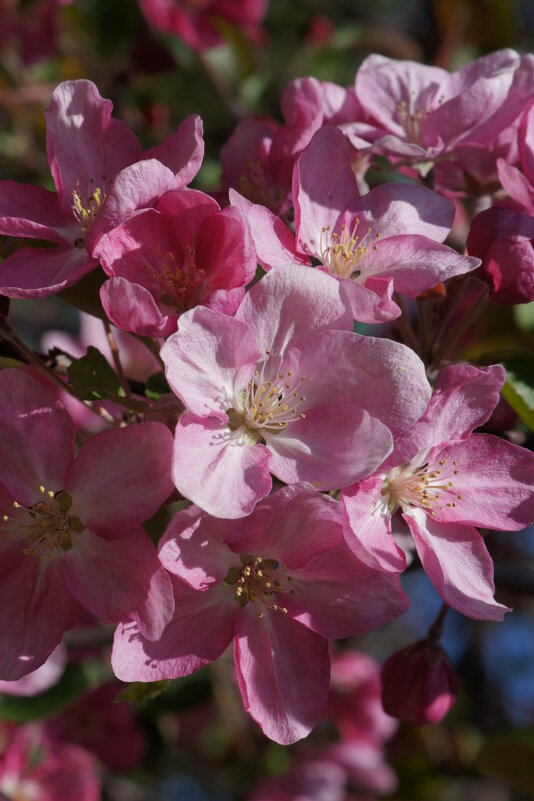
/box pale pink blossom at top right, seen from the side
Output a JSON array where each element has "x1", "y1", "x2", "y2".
[{"x1": 348, "y1": 50, "x2": 534, "y2": 161}]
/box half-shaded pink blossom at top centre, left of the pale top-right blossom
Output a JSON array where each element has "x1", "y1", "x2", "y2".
[{"x1": 221, "y1": 78, "x2": 359, "y2": 214}]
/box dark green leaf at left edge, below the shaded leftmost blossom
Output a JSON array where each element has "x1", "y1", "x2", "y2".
[{"x1": 0, "y1": 664, "x2": 90, "y2": 723}]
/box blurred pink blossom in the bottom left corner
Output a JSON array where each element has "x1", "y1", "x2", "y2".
[{"x1": 0, "y1": 725, "x2": 101, "y2": 801}]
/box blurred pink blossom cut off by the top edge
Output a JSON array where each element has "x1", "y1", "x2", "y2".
[{"x1": 139, "y1": 0, "x2": 268, "y2": 50}]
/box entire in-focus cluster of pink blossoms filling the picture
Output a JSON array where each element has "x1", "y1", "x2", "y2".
[{"x1": 0, "y1": 43, "x2": 534, "y2": 748}]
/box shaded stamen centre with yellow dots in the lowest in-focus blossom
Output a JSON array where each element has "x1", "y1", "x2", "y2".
[{"x1": 225, "y1": 553, "x2": 295, "y2": 618}]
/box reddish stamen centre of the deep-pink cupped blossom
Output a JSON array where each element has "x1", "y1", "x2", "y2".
[{"x1": 145, "y1": 245, "x2": 206, "y2": 313}]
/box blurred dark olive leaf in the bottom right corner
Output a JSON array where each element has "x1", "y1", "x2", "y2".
[{"x1": 475, "y1": 734, "x2": 534, "y2": 798}]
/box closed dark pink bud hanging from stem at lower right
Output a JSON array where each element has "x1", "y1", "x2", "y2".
[{"x1": 382, "y1": 640, "x2": 456, "y2": 725}]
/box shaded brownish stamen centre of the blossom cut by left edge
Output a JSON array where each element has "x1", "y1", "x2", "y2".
[{"x1": 1, "y1": 485, "x2": 85, "y2": 559}]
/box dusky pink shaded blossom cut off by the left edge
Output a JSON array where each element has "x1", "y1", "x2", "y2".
[{"x1": 0, "y1": 369, "x2": 173, "y2": 680}]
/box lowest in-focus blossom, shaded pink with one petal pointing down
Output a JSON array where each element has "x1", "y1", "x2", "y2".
[{"x1": 112, "y1": 484, "x2": 407, "y2": 743}]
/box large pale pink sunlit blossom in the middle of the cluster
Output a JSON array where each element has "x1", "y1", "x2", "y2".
[{"x1": 161, "y1": 260, "x2": 429, "y2": 518}]
